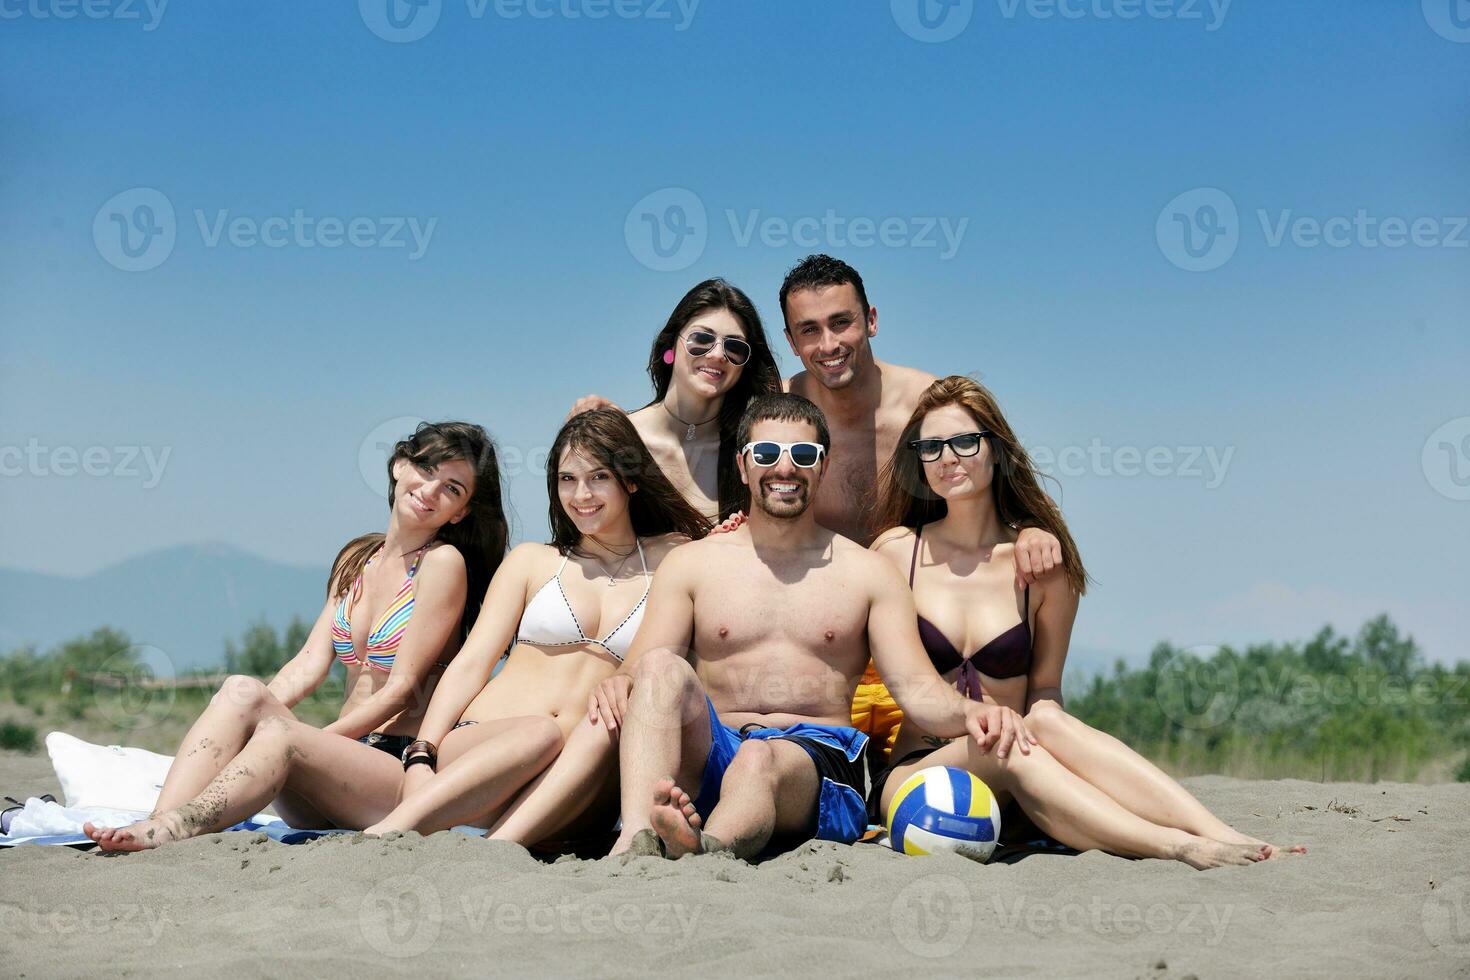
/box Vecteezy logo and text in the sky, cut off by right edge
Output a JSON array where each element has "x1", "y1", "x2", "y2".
[{"x1": 1154, "y1": 187, "x2": 1470, "y2": 272}]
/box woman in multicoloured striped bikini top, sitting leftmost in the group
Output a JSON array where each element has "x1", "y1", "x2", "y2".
[{"x1": 87, "y1": 422, "x2": 507, "y2": 851}]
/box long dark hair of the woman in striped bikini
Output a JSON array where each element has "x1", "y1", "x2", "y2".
[{"x1": 326, "y1": 422, "x2": 510, "y2": 636}]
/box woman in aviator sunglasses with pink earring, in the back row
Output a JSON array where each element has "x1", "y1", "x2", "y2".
[{"x1": 572, "y1": 279, "x2": 781, "y2": 520}]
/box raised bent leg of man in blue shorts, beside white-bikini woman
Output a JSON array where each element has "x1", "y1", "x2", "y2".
[{"x1": 613, "y1": 649, "x2": 713, "y2": 854}]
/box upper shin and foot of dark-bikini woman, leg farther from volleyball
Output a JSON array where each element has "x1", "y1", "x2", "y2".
[{"x1": 1026, "y1": 701, "x2": 1304, "y2": 852}]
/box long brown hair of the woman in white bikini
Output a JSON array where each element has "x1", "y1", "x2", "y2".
[{"x1": 547, "y1": 408, "x2": 710, "y2": 554}]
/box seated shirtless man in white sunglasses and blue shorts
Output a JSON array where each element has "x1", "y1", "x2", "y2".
[{"x1": 594, "y1": 394, "x2": 1032, "y2": 858}]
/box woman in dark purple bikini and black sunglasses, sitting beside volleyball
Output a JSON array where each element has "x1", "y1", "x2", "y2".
[{"x1": 870, "y1": 376, "x2": 1305, "y2": 867}]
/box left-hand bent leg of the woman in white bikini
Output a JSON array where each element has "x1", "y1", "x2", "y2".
[{"x1": 366, "y1": 716, "x2": 562, "y2": 833}]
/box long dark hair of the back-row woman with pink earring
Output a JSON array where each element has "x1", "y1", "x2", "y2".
[{"x1": 648, "y1": 279, "x2": 781, "y2": 517}]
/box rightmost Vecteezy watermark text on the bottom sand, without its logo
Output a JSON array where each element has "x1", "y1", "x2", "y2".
[{"x1": 991, "y1": 893, "x2": 1235, "y2": 946}]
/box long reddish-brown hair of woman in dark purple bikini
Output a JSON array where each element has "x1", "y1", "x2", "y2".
[{"x1": 875, "y1": 375, "x2": 1088, "y2": 595}]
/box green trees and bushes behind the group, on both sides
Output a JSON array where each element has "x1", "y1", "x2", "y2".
[{"x1": 0, "y1": 616, "x2": 1470, "y2": 782}]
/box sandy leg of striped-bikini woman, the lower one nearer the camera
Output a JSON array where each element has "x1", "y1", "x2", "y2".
[{"x1": 88, "y1": 717, "x2": 403, "y2": 851}]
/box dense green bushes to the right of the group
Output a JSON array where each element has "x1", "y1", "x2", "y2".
[{"x1": 1067, "y1": 616, "x2": 1470, "y2": 782}]
